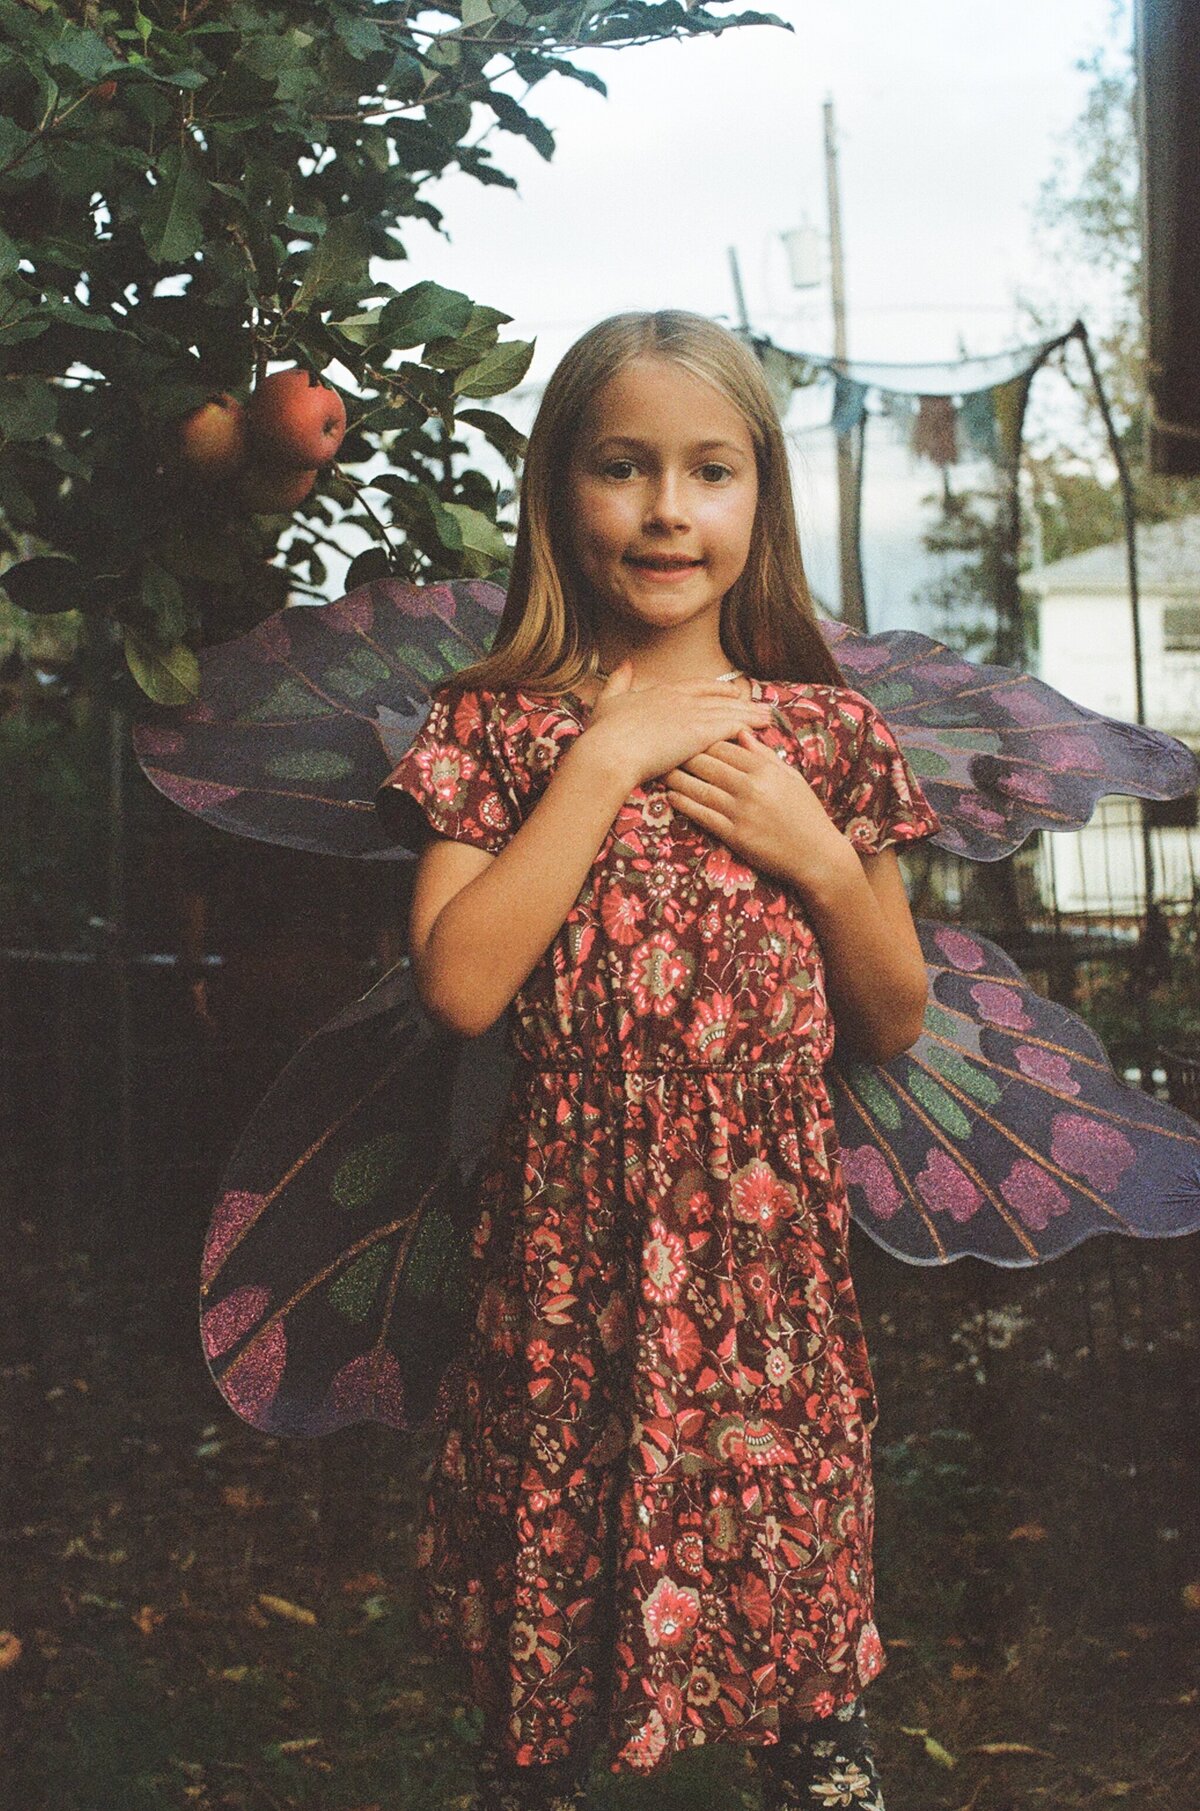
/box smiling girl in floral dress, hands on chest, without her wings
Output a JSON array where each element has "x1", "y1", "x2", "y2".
[{"x1": 380, "y1": 311, "x2": 938, "y2": 1811}]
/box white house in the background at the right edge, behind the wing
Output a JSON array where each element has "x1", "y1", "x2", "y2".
[{"x1": 1023, "y1": 516, "x2": 1200, "y2": 920}]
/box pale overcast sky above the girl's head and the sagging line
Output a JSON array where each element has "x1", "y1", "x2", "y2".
[{"x1": 407, "y1": 0, "x2": 1111, "y2": 382}]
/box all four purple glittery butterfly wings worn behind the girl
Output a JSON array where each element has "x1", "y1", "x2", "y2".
[{"x1": 134, "y1": 580, "x2": 1200, "y2": 1434}]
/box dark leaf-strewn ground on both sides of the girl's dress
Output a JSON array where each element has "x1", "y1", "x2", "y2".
[{"x1": 0, "y1": 1173, "x2": 1200, "y2": 1811}]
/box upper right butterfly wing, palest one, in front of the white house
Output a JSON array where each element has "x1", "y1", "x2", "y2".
[{"x1": 822, "y1": 621, "x2": 1200, "y2": 862}]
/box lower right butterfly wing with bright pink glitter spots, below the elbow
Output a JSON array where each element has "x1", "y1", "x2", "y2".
[{"x1": 829, "y1": 920, "x2": 1200, "y2": 1264}]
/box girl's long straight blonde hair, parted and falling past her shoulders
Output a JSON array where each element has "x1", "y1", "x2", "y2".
[{"x1": 452, "y1": 308, "x2": 845, "y2": 694}]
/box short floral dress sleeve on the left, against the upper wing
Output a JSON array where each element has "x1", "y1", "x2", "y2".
[{"x1": 375, "y1": 688, "x2": 518, "y2": 855}]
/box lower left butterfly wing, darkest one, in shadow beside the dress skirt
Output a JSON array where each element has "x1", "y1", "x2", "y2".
[{"x1": 201, "y1": 965, "x2": 510, "y2": 1434}]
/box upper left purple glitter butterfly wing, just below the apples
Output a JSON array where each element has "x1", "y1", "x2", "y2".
[{"x1": 134, "y1": 580, "x2": 505, "y2": 860}]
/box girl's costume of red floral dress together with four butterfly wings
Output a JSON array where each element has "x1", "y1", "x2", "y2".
[{"x1": 136, "y1": 581, "x2": 1200, "y2": 1771}]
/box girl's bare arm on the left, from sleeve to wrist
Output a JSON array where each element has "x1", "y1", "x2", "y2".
[{"x1": 409, "y1": 732, "x2": 637, "y2": 1038}]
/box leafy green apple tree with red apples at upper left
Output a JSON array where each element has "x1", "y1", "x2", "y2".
[{"x1": 0, "y1": 0, "x2": 780, "y2": 703}]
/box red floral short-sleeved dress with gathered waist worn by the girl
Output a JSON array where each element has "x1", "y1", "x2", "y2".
[{"x1": 387, "y1": 681, "x2": 938, "y2": 1773}]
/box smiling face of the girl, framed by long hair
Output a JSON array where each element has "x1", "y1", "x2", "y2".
[{"x1": 567, "y1": 357, "x2": 758, "y2": 630}]
